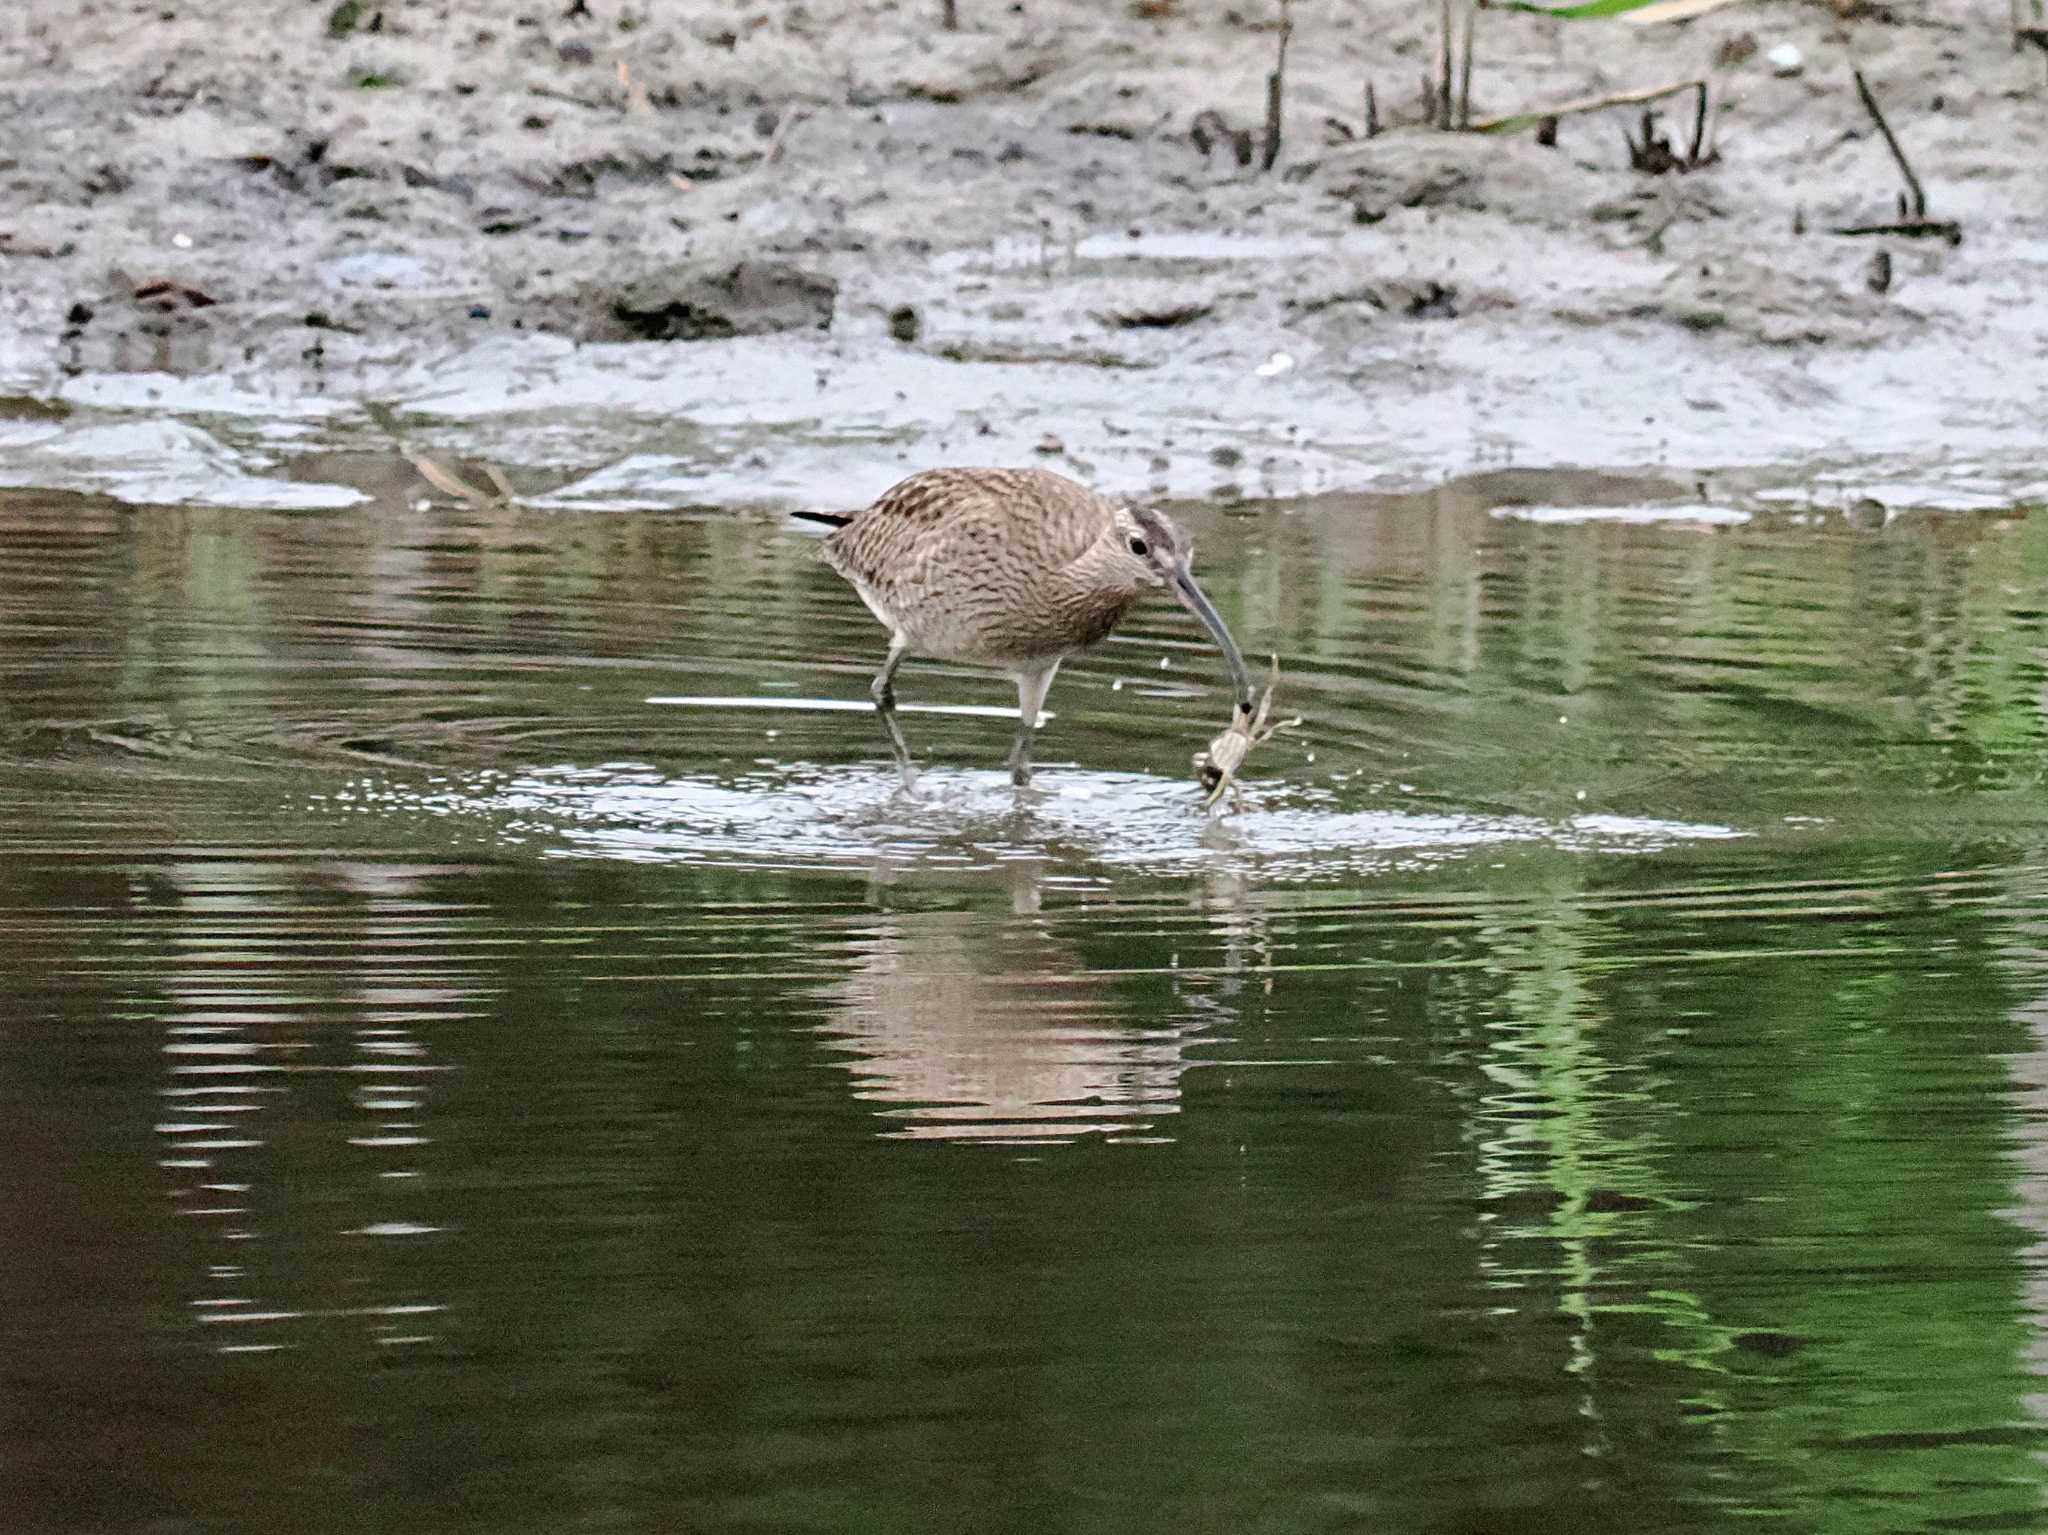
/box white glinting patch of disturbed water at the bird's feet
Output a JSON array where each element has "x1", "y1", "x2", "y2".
[{"x1": 364, "y1": 761, "x2": 1745, "y2": 882}]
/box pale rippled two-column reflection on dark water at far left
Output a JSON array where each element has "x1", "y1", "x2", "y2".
[{"x1": 156, "y1": 860, "x2": 479, "y2": 1353}]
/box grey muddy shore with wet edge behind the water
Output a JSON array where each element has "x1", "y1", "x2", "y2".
[{"x1": 0, "y1": 0, "x2": 2048, "y2": 506}]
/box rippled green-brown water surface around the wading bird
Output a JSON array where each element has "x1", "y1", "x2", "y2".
[{"x1": 0, "y1": 473, "x2": 2048, "y2": 1531}]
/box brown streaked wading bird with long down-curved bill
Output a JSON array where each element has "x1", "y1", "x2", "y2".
[{"x1": 799, "y1": 469, "x2": 1251, "y2": 786}]
